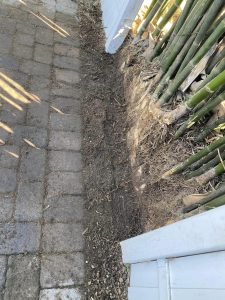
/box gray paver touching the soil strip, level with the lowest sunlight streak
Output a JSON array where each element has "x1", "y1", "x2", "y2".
[{"x1": 48, "y1": 151, "x2": 82, "y2": 172}]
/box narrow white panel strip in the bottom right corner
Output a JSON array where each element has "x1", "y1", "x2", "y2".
[{"x1": 171, "y1": 289, "x2": 225, "y2": 300}]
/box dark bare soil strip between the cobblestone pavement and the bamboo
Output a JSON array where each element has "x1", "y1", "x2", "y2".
[{"x1": 80, "y1": 1, "x2": 142, "y2": 300}]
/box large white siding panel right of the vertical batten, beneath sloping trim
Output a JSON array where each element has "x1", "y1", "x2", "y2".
[{"x1": 169, "y1": 252, "x2": 225, "y2": 290}]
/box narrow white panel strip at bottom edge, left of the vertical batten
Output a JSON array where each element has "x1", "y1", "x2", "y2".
[{"x1": 128, "y1": 288, "x2": 158, "y2": 300}]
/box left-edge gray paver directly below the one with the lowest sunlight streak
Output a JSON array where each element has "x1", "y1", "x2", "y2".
[{"x1": 0, "y1": 168, "x2": 16, "y2": 193}]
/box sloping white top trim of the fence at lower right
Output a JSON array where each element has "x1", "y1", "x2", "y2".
[{"x1": 121, "y1": 206, "x2": 225, "y2": 263}]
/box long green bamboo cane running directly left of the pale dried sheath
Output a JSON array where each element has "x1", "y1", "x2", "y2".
[{"x1": 161, "y1": 14, "x2": 225, "y2": 103}]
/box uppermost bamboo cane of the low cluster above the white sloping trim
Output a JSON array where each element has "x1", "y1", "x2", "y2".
[{"x1": 163, "y1": 136, "x2": 225, "y2": 178}]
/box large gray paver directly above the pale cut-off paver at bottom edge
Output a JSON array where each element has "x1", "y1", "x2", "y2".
[{"x1": 41, "y1": 253, "x2": 84, "y2": 288}]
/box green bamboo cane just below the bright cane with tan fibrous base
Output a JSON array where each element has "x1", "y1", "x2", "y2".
[{"x1": 175, "y1": 92, "x2": 225, "y2": 139}]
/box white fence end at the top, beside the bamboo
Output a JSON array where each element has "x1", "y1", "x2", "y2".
[{"x1": 101, "y1": 0, "x2": 144, "y2": 54}]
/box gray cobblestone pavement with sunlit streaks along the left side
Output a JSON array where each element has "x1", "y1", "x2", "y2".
[{"x1": 0, "y1": 0, "x2": 84, "y2": 300}]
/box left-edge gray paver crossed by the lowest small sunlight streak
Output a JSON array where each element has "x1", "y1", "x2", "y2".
[{"x1": 0, "y1": 146, "x2": 19, "y2": 168}]
